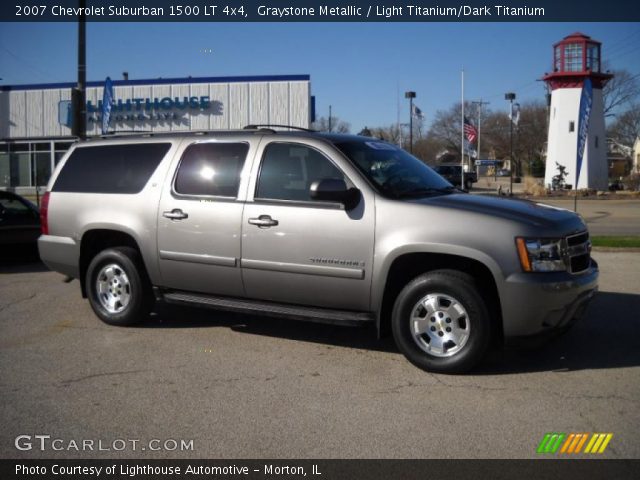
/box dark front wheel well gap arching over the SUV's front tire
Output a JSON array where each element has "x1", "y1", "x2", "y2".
[{"x1": 377, "y1": 252, "x2": 504, "y2": 342}]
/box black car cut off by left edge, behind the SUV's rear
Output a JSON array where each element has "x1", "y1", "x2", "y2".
[{"x1": 0, "y1": 191, "x2": 40, "y2": 254}]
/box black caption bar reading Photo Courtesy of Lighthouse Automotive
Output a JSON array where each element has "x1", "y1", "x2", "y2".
[{"x1": 0, "y1": 459, "x2": 640, "y2": 480}]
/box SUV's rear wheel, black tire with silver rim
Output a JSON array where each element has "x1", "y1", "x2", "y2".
[{"x1": 85, "y1": 247, "x2": 153, "y2": 326}]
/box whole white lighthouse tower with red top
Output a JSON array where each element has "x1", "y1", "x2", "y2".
[{"x1": 543, "y1": 33, "x2": 612, "y2": 190}]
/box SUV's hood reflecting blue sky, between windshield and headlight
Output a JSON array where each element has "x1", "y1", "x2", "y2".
[{"x1": 415, "y1": 193, "x2": 586, "y2": 233}]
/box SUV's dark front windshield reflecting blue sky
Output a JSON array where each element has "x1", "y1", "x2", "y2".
[{"x1": 335, "y1": 139, "x2": 455, "y2": 198}]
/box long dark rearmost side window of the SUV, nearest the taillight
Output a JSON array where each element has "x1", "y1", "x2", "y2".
[{"x1": 52, "y1": 143, "x2": 171, "y2": 193}]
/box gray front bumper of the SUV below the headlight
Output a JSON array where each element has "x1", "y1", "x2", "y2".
[{"x1": 501, "y1": 259, "x2": 598, "y2": 343}]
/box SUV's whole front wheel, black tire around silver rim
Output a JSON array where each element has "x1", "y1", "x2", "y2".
[{"x1": 391, "y1": 270, "x2": 491, "y2": 373}]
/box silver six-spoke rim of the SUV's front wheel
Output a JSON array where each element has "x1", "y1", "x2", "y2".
[{"x1": 409, "y1": 293, "x2": 471, "y2": 357}]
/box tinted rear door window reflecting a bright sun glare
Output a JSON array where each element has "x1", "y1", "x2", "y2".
[{"x1": 174, "y1": 143, "x2": 249, "y2": 197}]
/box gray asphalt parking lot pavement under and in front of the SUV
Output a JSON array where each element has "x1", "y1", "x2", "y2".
[{"x1": 0, "y1": 252, "x2": 640, "y2": 458}]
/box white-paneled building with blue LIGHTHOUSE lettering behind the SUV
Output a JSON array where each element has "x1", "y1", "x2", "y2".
[{"x1": 0, "y1": 75, "x2": 313, "y2": 192}]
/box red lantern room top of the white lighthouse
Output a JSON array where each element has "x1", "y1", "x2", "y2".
[{"x1": 542, "y1": 32, "x2": 613, "y2": 90}]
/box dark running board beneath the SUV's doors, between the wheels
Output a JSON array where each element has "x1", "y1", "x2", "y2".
[{"x1": 156, "y1": 290, "x2": 374, "y2": 326}]
